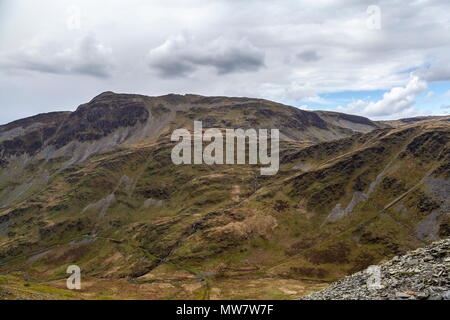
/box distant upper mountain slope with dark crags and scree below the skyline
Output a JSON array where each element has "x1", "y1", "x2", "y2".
[{"x1": 0, "y1": 92, "x2": 378, "y2": 207}]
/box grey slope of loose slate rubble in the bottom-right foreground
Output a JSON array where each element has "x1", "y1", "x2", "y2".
[{"x1": 302, "y1": 239, "x2": 450, "y2": 300}]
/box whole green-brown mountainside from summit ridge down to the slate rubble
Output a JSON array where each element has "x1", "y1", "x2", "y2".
[{"x1": 0, "y1": 92, "x2": 450, "y2": 299}]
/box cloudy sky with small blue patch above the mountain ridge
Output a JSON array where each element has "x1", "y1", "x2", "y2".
[{"x1": 0, "y1": 0, "x2": 450, "y2": 123}]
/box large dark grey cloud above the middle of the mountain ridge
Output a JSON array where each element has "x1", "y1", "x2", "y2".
[{"x1": 147, "y1": 35, "x2": 264, "y2": 78}]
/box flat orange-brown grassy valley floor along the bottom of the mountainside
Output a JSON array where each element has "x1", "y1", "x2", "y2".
[{"x1": 0, "y1": 273, "x2": 328, "y2": 300}]
